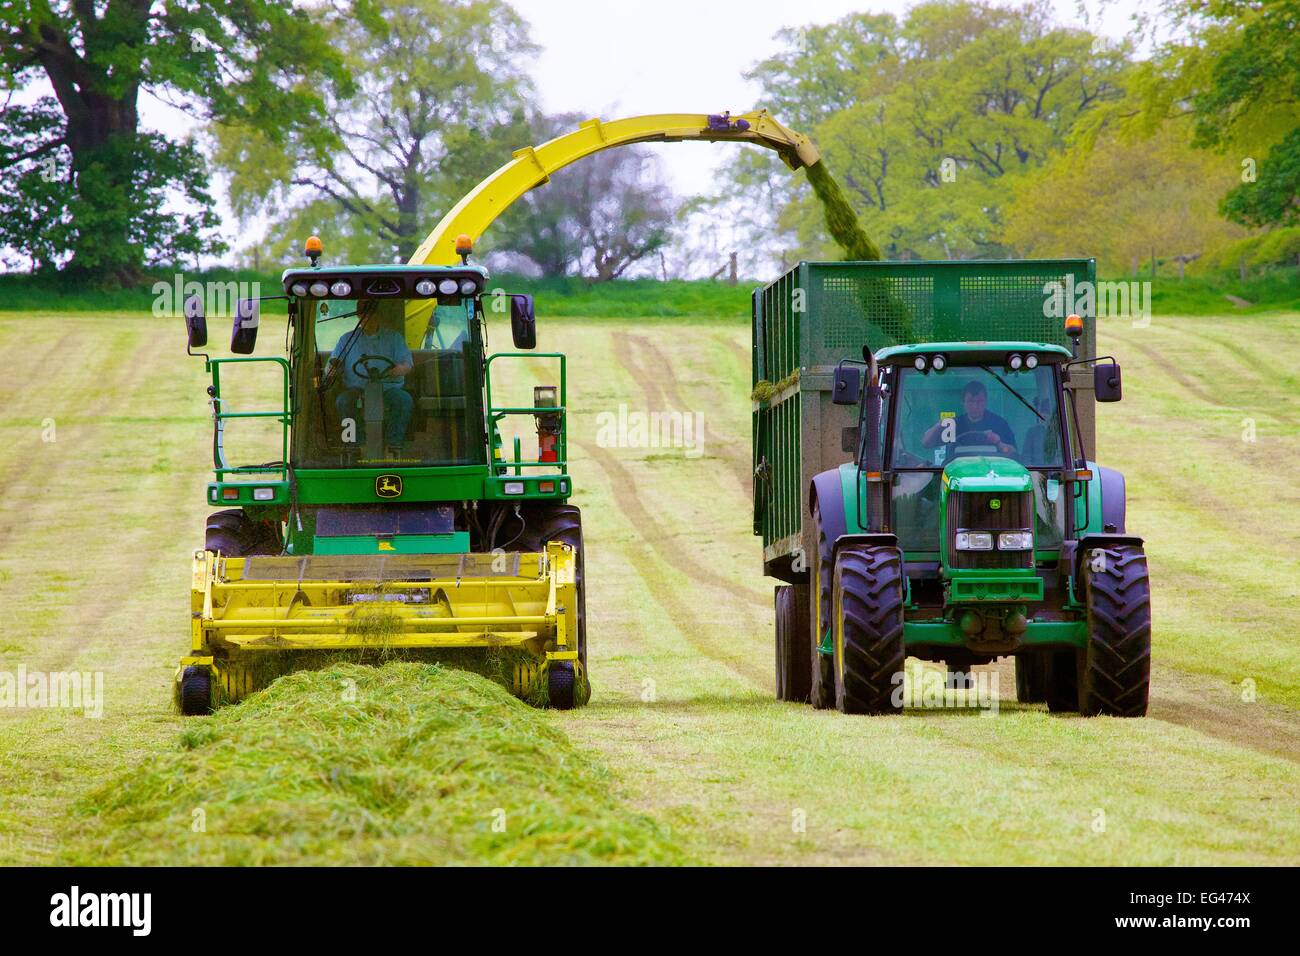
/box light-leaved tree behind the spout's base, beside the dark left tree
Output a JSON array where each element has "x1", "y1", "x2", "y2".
[{"x1": 213, "y1": 0, "x2": 536, "y2": 260}]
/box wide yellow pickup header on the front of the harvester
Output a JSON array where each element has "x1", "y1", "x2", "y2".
[{"x1": 177, "y1": 542, "x2": 579, "y2": 700}]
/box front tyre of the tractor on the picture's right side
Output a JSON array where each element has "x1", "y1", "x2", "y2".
[{"x1": 1079, "y1": 545, "x2": 1151, "y2": 717}]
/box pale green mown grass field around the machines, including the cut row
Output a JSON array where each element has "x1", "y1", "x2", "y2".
[{"x1": 0, "y1": 308, "x2": 1300, "y2": 865}]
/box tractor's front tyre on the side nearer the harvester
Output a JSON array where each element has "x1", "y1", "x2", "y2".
[{"x1": 832, "y1": 545, "x2": 906, "y2": 714}]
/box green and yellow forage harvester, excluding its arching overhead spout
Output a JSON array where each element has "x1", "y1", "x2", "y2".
[{"x1": 177, "y1": 237, "x2": 589, "y2": 714}]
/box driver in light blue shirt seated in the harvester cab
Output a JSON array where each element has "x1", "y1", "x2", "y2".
[{"x1": 325, "y1": 299, "x2": 415, "y2": 449}]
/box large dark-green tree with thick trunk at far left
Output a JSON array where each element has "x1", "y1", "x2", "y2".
[{"x1": 0, "y1": 0, "x2": 337, "y2": 284}]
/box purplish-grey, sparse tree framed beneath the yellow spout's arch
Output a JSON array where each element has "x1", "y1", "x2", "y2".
[{"x1": 489, "y1": 113, "x2": 673, "y2": 281}]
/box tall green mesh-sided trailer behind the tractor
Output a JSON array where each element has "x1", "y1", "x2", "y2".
[{"x1": 753, "y1": 259, "x2": 1096, "y2": 581}]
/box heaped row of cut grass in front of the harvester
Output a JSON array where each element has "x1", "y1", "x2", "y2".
[{"x1": 61, "y1": 662, "x2": 690, "y2": 865}]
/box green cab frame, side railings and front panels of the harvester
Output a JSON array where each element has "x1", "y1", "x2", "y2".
[{"x1": 207, "y1": 265, "x2": 573, "y2": 554}]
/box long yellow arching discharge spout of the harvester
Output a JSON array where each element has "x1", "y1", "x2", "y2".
[{"x1": 407, "y1": 109, "x2": 820, "y2": 342}]
